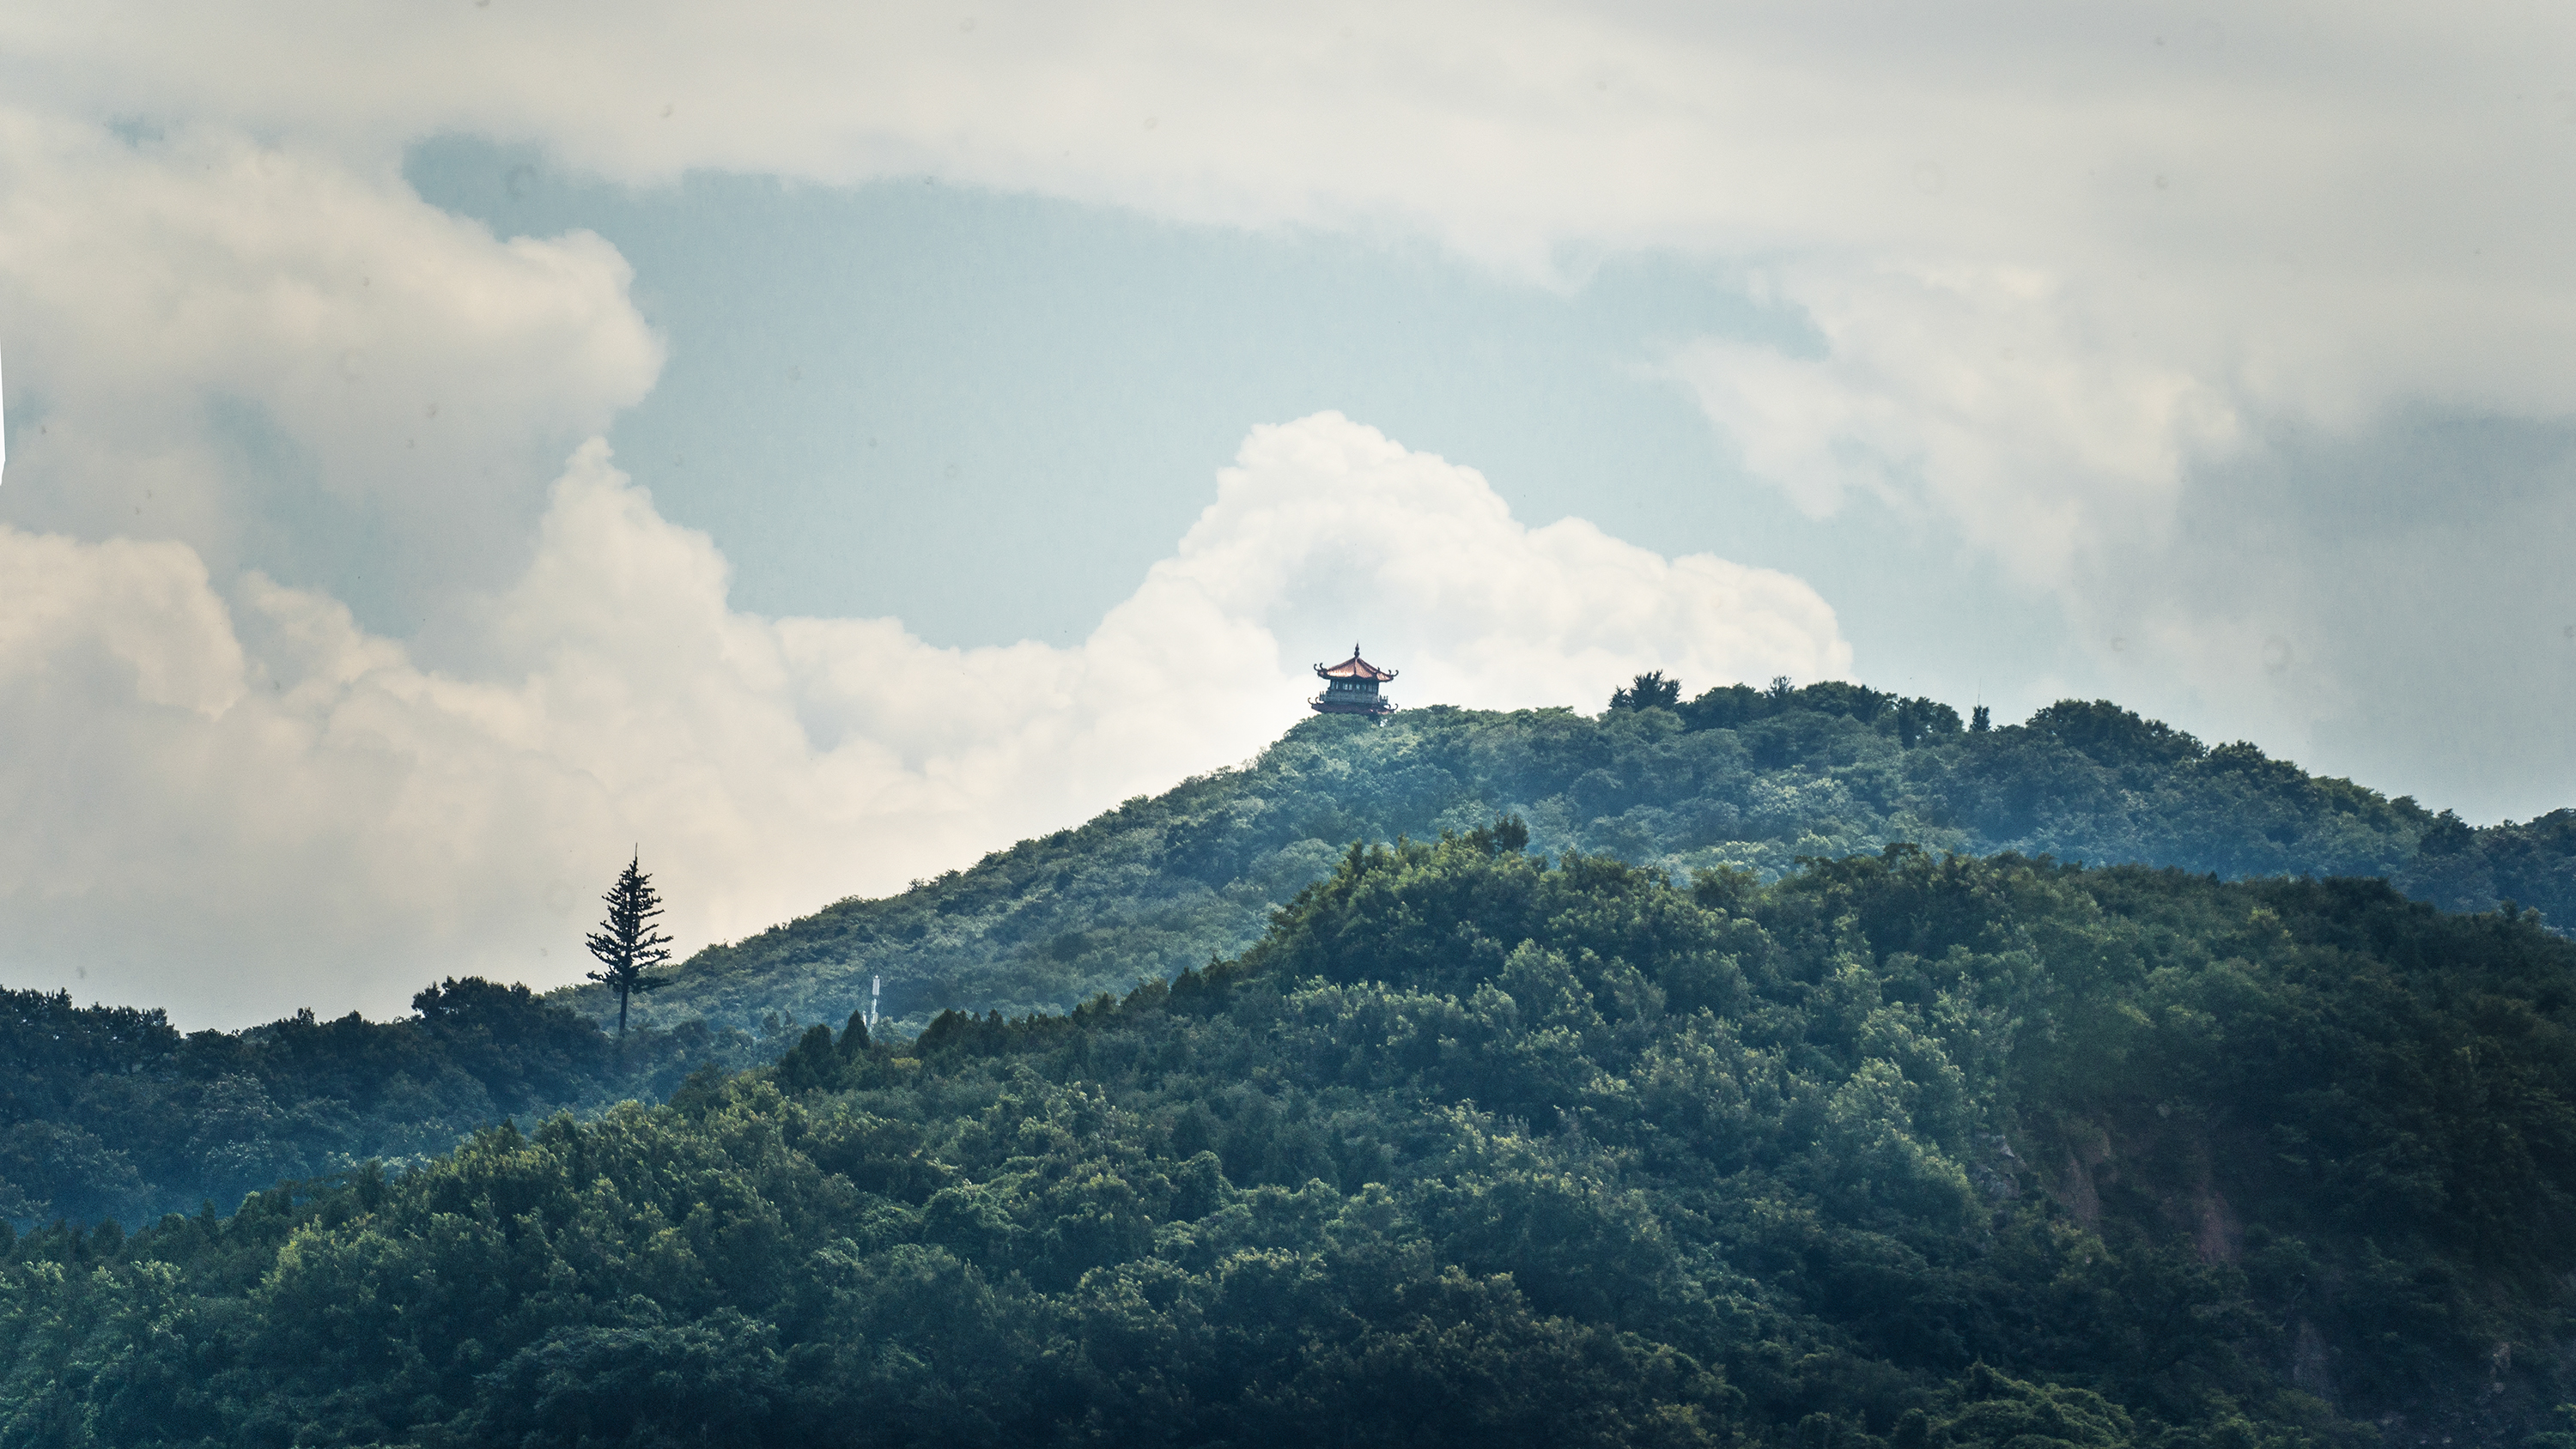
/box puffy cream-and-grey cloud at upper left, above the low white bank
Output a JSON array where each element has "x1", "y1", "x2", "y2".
[{"x1": 0, "y1": 111, "x2": 662, "y2": 615}]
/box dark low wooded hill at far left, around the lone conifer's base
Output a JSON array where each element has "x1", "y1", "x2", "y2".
[{"x1": 0, "y1": 978, "x2": 775, "y2": 1222}]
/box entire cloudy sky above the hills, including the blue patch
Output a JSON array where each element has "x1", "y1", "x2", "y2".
[{"x1": 0, "y1": 0, "x2": 2576, "y2": 1027}]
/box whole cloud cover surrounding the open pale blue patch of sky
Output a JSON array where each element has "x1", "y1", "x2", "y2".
[{"x1": 0, "y1": 0, "x2": 2576, "y2": 1019}]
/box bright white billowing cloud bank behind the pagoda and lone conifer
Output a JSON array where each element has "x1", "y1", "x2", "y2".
[{"x1": 0, "y1": 415, "x2": 1850, "y2": 1024}]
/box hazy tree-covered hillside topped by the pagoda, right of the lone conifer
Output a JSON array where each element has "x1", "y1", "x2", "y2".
[{"x1": 564, "y1": 677, "x2": 2576, "y2": 1029}]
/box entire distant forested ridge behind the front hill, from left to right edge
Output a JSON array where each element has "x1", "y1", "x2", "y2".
[{"x1": 0, "y1": 677, "x2": 2576, "y2": 1246}]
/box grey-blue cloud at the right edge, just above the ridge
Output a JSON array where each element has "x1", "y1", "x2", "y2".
[{"x1": 2030, "y1": 417, "x2": 2576, "y2": 821}]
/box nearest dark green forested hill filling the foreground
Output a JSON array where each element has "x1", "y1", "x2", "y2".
[{"x1": 0, "y1": 839, "x2": 2576, "y2": 1449}]
